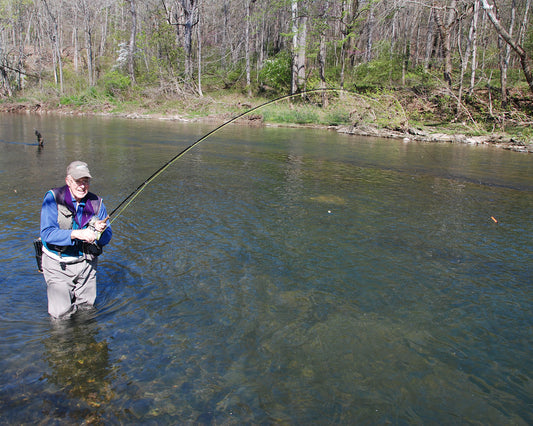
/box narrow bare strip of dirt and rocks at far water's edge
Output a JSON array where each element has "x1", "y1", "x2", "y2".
[{"x1": 0, "y1": 103, "x2": 533, "y2": 153}]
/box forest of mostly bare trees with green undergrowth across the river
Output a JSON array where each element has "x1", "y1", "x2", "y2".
[{"x1": 0, "y1": 0, "x2": 533, "y2": 143}]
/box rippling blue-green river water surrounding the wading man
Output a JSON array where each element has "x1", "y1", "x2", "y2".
[{"x1": 0, "y1": 115, "x2": 533, "y2": 425}]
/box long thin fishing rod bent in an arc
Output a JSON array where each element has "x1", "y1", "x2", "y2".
[{"x1": 109, "y1": 88, "x2": 348, "y2": 224}]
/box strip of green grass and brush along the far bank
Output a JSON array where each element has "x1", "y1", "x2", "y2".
[{"x1": 4, "y1": 75, "x2": 533, "y2": 143}]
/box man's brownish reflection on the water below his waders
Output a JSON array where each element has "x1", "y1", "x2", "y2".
[{"x1": 43, "y1": 311, "x2": 114, "y2": 421}]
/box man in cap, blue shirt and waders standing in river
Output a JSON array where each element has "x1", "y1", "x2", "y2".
[{"x1": 41, "y1": 161, "x2": 112, "y2": 318}]
